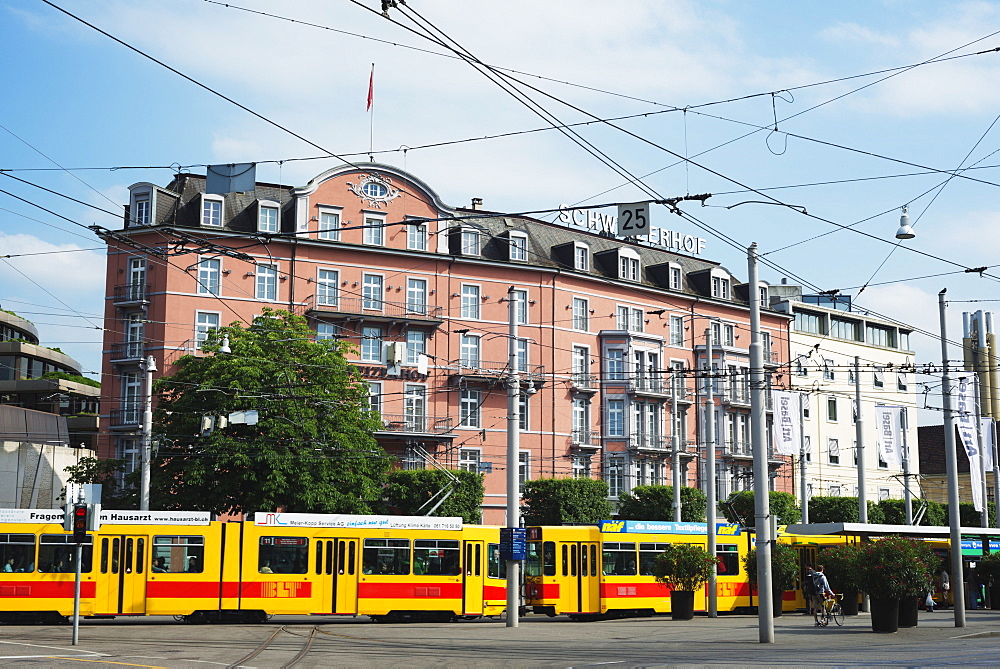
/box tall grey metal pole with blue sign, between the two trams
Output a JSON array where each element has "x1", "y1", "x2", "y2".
[{"x1": 507, "y1": 286, "x2": 521, "y2": 627}]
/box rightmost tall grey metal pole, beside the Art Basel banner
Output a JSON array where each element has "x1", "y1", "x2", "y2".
[{"x1": 938, "y1": 288, "x2": 965, "y2": 627}]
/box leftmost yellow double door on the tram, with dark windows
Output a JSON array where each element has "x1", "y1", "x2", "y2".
[{"x1": 94, "y1": 534, "x2": 148, "y2": 615}]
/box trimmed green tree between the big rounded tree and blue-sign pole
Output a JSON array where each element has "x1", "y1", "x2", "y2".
[{"x1": 385, "y1": 469, "x2": 485, "y2": 524}]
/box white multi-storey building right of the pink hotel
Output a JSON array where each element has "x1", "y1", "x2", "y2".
[{"x1": 771, "y1": 284, "x2": 919, "y2": 502}]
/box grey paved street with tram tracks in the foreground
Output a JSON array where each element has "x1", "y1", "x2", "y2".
[{"x1": 0, "y1": 611, "x2": 1000, "y2": 669}]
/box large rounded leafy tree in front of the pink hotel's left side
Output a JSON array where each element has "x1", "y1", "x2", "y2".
[{"x1": 151, "y1": 309, "x2": 389, "y2": 513}]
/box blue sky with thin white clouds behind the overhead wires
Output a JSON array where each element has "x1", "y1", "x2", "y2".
[{"x1": 0, "y1": 0, "x2": 1000, "y2": 418}]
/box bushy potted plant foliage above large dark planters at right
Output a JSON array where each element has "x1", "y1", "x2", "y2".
[{"x1": 857, "y1": 537, "x2": 938, "y2": 599}]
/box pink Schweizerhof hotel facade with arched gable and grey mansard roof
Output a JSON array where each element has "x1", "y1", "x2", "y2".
[{"x1": 102, "y1": 164, "x2": 791, "y2": 523}]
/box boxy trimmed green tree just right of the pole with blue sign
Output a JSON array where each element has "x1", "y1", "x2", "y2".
[{"x1": 523, "y1": 479, "x2": 614, "y2": 525}]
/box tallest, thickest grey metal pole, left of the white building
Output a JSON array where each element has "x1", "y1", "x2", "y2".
[{"x1": 747, "y1": 242, "x2": 774, "y2": 643}]
